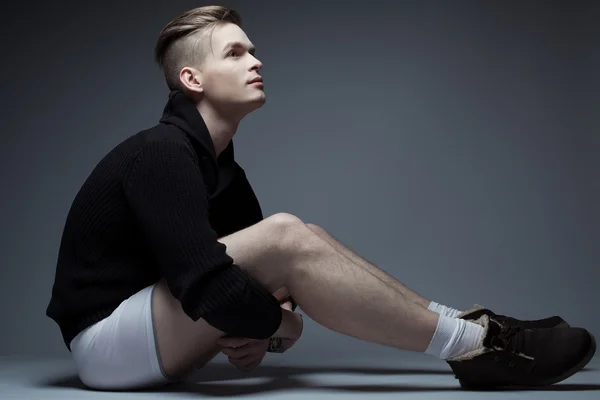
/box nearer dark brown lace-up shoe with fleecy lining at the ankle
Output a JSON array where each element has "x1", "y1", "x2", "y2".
[{"x1": 446, "y1": 315, "x2": 596, "y2": 390}]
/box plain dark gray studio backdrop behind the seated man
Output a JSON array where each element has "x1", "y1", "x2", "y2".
[{"x1": 0, "y1": 1, "x2": 600, "y2": 360}]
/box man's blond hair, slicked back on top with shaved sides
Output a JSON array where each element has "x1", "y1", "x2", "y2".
[{"x1": 154, "y1": 6, "x2": 242, "y2": 90}]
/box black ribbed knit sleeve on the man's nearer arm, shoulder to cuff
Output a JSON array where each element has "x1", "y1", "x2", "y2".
[{"x1": 125, "y1": 139, "x2": 281, "y2": 339}]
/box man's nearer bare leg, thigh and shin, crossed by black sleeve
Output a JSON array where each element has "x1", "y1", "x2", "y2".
[{"x1": 154, "y1": 214, "x2": 439, "y2": 376}]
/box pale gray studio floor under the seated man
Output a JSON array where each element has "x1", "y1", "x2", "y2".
[{"x1": 0, "y1": 353, "x2": 600, "y2": 400}]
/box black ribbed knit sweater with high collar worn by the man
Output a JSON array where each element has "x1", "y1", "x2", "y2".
[{"x1": 46, "y1": 91, "x2": 281, "y2": 350}]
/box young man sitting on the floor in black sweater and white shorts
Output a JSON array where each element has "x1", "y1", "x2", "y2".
[{"x1": 47, "y1": 6, "x2": 595, "y2": 390}]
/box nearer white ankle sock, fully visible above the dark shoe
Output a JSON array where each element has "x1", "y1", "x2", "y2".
[{"x1": 425, "y1": 315, "x2": 483, "y2": 360}]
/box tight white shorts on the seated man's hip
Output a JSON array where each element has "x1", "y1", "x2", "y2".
[{"x1": 71, "y1": 285, "x2": 172, "y2": 390}]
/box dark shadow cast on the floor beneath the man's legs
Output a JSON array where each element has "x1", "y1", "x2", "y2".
[{"x1": 42, "y1": 364, "x2": 600, "y2": 397}]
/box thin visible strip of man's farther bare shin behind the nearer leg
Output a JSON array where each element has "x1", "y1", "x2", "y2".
[{"x1": 306, "y1": 224, "x2": 431, "y2": 308}]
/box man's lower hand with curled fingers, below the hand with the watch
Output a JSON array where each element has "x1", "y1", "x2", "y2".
[{"x1": 217, "y1": 337, "x2": 269, "y2": 372}]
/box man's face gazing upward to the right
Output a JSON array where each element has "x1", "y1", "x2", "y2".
[{"x1": 195, "y1": 23, "x2": 266, "y2": 116}]
